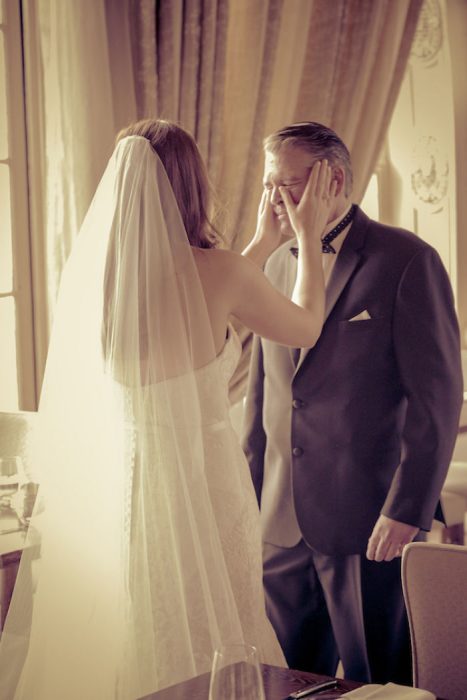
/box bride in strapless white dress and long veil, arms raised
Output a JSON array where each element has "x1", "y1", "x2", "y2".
[{"x1": 0, "y1": 120, "x2": 333, "y2": 700}]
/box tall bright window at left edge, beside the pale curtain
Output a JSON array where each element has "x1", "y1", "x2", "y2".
[{"x1": 0, "y1": 0, "x2": 36, "y2": 410}]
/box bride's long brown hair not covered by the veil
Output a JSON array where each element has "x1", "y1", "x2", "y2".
[{"x1": 117, "y1": 119, "x2": 221, "y2": 248}]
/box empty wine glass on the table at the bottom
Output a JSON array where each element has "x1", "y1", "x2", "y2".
[{"x1": 209, "y1": 644, "x2": 265, "y2": 700}]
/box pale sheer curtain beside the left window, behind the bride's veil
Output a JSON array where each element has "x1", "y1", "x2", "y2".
[{"x1": 23, "y1": 0, "x2": 136, "y2": 395}]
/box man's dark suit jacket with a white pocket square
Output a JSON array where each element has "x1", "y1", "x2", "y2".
[{"x1": 244, "y1": 205, "x2": 462, "y2": 554}]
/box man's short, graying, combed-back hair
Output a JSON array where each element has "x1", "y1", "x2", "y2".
[{"x1": 263, "y1": 122, "x2": 353, "y2": 196}]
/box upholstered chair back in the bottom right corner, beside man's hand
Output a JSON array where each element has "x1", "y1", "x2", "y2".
[{"x1": 402, "y1": 542, "x2": 467, "y2": 700}]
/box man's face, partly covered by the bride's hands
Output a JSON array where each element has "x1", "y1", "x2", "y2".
[{"x1": 263, "y1": 146, "x2": 316, "y2": 235}]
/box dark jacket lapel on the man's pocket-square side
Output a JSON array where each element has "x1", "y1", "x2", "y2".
[{"x1": 295, "y1": 209, "x2": 370, "y2": 374}]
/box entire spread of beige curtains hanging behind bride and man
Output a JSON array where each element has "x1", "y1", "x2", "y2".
[{"x1": 25, "y1": 0, "x2": 422, "y2": 399}]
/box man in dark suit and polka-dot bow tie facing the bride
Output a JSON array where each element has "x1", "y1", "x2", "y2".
[{"x1": 244, "y1": 122, "x2": 462, "y2": 685}]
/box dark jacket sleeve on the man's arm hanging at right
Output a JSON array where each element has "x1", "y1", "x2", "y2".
[{"x1": 382, "y1": 247, "x2": 463, "y2": 530}]
